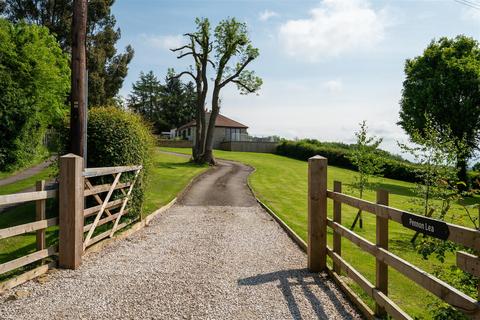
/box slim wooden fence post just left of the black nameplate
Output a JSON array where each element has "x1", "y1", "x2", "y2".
[{"x1": 375, "y1": 190, "x2": 388, "y2": 316}]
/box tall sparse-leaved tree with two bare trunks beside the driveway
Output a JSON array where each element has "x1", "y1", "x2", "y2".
[{"x1": 173, "y1": 18, "x2": 262, "y2": 163}]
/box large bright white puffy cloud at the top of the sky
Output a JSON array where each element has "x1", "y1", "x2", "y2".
[{"x1": 279, "y1": 0, "x2": 388, "y2": 60}]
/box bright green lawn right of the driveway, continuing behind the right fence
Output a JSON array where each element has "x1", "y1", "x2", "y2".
[{"x1": 161, "y1": 148, "x2": 480, "y2": 319}]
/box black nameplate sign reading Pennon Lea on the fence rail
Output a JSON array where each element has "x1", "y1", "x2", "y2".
[{"x1": 402, "y1": 212, "x2": 450, "y2": 240}]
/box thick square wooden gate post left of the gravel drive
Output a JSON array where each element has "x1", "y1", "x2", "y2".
[{"x1": 58, "y1": 153, "x2": 84, "y2": 269}]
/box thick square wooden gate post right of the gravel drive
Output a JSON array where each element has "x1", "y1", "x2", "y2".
[{"x1": 307, "y1": 156, "x2": 327, "y2": 272}]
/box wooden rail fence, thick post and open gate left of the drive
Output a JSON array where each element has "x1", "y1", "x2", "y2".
[{"x1": 0, "y1": 154, "x2": 142, "y2": 286}]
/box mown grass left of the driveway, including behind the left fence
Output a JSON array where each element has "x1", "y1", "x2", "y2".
[{"x1": 0, "y1": 150, "x2": 208, "y2": 281}]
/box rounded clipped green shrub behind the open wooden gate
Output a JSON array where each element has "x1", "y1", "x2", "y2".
[{"x1": 87, "y1": 107, "x2": 154, "y2": 216}]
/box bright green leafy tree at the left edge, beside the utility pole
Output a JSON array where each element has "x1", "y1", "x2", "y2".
[{"x1": 0, "y1": 19, "x2": 70, "y2": 170}]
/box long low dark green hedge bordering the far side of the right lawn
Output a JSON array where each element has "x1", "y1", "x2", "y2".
[{"x1": 277, "y1": 139, "x2": 418, "y2": 182}]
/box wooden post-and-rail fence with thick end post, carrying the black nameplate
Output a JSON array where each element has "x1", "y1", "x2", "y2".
[{"x1": 307, "y1": 156, "x2": 480, "y2": 319}]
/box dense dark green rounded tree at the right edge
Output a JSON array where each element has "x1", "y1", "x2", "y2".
[{"x1": 399, "y1": 35, "x2": 480, "y2": 182}]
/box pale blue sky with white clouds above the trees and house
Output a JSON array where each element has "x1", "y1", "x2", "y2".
[{"x1": 113, "y1": 0, "x2": 480, "y2": 156}]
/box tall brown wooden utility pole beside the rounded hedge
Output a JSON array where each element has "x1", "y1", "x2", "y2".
[{"x1": 70, "y1": 0, "x2": 87, "y2": 157}]
